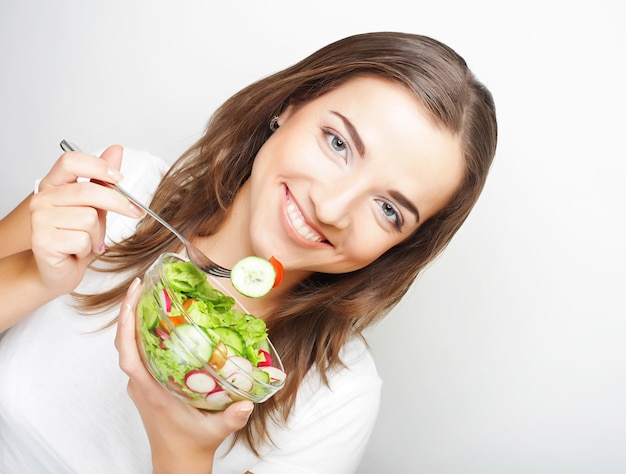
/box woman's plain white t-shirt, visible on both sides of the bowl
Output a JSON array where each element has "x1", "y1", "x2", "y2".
[{"x1": 0, "y1": 150, "x2": 381, "y2": 474}]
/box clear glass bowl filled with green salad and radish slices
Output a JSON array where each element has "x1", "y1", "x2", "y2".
[{"x1": 136, "y1": 253, "x2": 286, "y2": 410}]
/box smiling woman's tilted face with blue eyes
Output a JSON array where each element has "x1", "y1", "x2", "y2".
[{"x1": 242, "y1": 77, "x2": 463, "y2": 273}]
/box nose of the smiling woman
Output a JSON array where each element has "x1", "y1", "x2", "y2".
[{"x1": 311, "y1": 179, "x2": 361, "y2": 229}]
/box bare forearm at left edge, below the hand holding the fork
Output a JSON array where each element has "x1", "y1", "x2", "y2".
[{"x1": 0, "y1": 250, "x2": 58, "y2": 332}]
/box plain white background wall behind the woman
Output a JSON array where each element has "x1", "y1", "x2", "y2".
[{"x1": 0, "y1": 0, "x2": 626, "y2": 474}]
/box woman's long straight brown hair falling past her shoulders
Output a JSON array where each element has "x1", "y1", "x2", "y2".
[{"x1": 80, "y1": 32, "x2": 497, "y2": 451}]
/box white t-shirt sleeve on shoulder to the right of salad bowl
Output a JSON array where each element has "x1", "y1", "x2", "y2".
[{"x1": 250, "y1": 338, "x2": 382, "y2": 474}]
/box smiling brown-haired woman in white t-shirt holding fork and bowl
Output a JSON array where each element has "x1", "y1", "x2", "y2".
[{"x1": 0, "y1": 33, "x2": 497, "y2": 473}]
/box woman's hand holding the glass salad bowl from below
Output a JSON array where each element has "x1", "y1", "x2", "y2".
[{"x1": 115, "y1": 279, "x2": 253, "y2": 473}]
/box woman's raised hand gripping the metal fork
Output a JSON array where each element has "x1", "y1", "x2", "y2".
[{"x1": 30, "y1": 145, "x2": 143, "y2": 295}]
